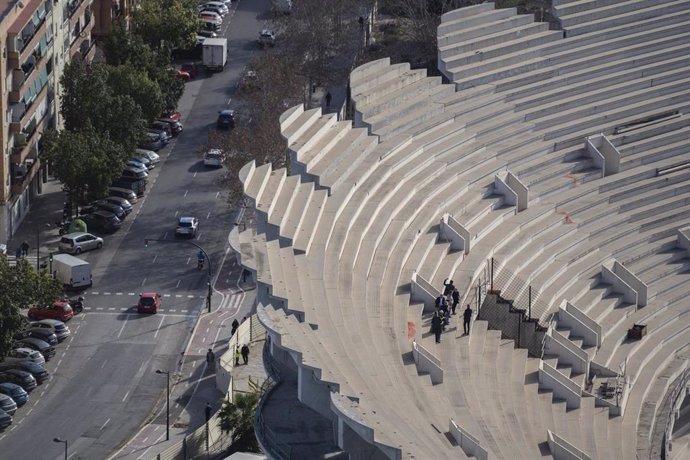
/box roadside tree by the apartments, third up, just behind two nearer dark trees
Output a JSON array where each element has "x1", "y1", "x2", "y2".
[{"x1": 108, "y1": 64, "x2": 164, "y2": 122}]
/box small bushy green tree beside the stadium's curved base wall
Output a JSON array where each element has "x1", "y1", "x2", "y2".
[{"x1": 218, "y1": 393, "x2": 259, "y2": 452}]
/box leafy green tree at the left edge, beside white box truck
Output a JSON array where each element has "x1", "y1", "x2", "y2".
[{"x1": 0, "y1": 256, "x2": 62, "y2": 359}]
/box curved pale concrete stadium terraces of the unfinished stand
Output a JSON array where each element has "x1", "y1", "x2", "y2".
[{"x1": 240, "y1": 0, "x2": 690, "y2": 460}]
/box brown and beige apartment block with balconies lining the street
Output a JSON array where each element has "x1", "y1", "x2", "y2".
[{"x1": 0, "y1": 0, "x2": 96, "y2": 242}]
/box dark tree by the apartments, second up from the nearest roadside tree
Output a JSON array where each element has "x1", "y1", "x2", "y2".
[{"x1": 60, "y1": 60, "x2": 145, "y2": 152}]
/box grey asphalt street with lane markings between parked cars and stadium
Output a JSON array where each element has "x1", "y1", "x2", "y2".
[{"x1": 0, "y1": 0, "x2": 269, "y2": 460}]
